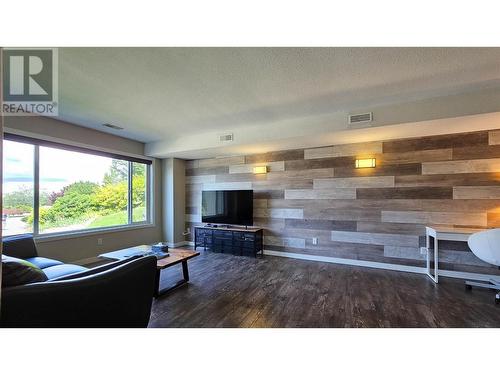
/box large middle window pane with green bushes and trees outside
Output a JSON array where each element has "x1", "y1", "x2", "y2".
[{"x1": 39, "y1": 147, "x2": 129, "y2": 233}]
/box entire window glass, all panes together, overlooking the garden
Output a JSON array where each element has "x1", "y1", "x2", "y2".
[{"x1": 2, "y1": 140, "x2": 150, "y2": 236}]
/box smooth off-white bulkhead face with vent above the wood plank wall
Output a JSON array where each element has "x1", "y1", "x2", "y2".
[{"x1": 145, "y1": 89, "x2": 500, "y2": 159}]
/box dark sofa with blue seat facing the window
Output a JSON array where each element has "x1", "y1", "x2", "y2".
[{"x1": 0, "y1": 236, "x2": 156, "y2": 327}]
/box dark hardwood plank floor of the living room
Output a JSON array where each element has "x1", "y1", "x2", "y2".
[{"x1": 150, "y1": 252, "x2": 500, "y2": 327}]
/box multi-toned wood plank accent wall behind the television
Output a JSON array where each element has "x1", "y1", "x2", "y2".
[{"x1": 186, "y1": 130, "x2": 500, "y2": 274}]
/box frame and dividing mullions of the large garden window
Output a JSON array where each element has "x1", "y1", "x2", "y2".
[{"x1": 2, "y1": 133, "x2": 155, "y2": 242}]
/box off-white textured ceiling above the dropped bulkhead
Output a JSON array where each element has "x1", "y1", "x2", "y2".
[{"x1": 55, "y1": 48, "x2": 500, "y2": 142}]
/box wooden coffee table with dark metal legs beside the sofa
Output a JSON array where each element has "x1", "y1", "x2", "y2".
[{"x1": 99, "y1": 245, "x2": 200, "y2": 298}]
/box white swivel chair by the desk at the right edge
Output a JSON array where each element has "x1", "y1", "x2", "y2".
[{"x1": 465, "y1": 229, "x2": 500, "y2": 303}]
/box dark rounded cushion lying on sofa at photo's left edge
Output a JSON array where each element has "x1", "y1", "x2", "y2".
[{"x1": 2, "y1": 255, "x2": 48, "y2": 287}]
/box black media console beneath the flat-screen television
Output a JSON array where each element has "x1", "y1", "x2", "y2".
[{"x1": 194, "y1": 226, "x2": 264, "y2": 256}]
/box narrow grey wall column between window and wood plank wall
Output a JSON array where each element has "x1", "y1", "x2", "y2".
[{"x1": 162, "y1": 158, "x2": 186, "y2": 246}]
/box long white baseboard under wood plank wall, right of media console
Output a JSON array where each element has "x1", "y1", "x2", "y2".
[{"x1": 264, "y1": 250, "x2": 498, "y2": 281}]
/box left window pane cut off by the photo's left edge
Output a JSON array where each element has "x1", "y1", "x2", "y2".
[{"x1": 2, "y1": 141, "x2": 35, "y2": 236}]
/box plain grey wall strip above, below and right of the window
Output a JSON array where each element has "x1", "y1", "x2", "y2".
[{"x1": 5, "y1": 117, "x2": 162, "y2": 262}]
